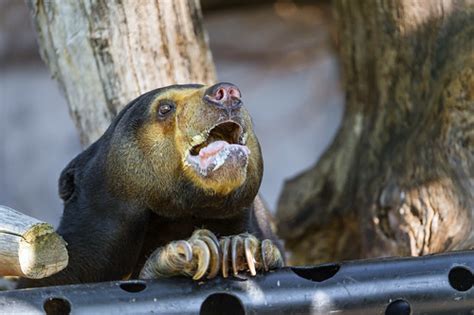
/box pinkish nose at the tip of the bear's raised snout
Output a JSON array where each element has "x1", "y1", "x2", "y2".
[{"x1": 204, "y1": 82, "x2": 242, "y2": 110}]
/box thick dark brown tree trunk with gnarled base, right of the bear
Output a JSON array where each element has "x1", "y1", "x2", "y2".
[{"x1": 278, "y1": 0, "x2": 474, "y2": 263}]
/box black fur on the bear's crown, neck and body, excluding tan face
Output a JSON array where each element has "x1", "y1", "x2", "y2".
[{"x1": 20, "y1": 85, "x2": 278, "y2": 287}]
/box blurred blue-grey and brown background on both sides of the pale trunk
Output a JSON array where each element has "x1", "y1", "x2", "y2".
[{"x1": 0, "y1": 0, "x2": 343, "y2": 226}]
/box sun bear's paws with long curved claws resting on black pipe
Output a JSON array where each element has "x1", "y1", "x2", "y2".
[{"x1": 140, "y1": 229, "x2": 283, "y2": 280}]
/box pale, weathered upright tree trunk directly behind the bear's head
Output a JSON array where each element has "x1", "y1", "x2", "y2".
[{"x1": 27, "y1": 0, "x2": 215, "y2": 146}]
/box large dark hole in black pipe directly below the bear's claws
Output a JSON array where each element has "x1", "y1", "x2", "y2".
[{"x1": 199, "y1": 293, "x2": 245, "y2": 315}]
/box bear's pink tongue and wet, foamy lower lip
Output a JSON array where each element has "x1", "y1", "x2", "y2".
[{"x1": 186, "y1": 140, "x2": 250, "y2": 180}]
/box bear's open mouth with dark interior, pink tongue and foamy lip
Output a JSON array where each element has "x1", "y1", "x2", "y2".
[{"x1": 186, "y1": 121, "x2": 250, "y2": 176}]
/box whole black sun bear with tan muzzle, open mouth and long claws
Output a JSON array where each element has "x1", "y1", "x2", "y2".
[{"x1": 20, "y1": 83, "x2": 283, "y2": 287}]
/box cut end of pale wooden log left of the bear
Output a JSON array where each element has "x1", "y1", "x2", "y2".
[{"x1": 0, "y1": 206, "x2": 68, "y2": 279}]
